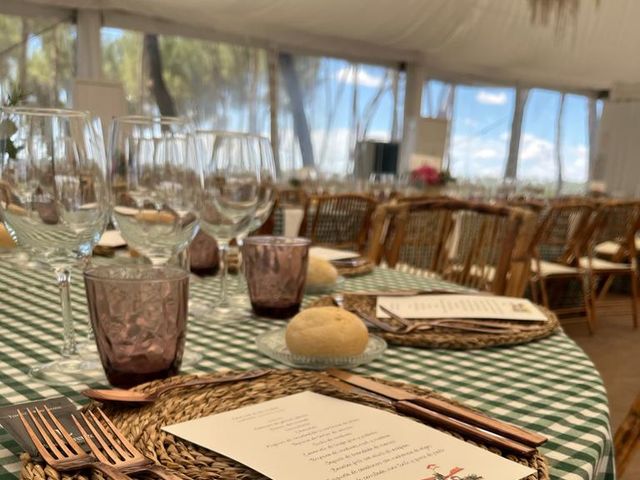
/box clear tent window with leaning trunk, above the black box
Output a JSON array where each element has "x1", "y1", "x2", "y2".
[{"x1": 278, "y1": 56, "x2": 405, "y2": 175}]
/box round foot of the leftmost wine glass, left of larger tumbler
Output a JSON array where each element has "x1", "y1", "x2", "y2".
[{"x1": 29, "y1": 355, "x2": 107, "y2": 386}]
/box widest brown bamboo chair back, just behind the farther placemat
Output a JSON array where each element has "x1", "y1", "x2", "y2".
[{"x1": 374, "y1": 199, "x2": 535, "y2": 296}]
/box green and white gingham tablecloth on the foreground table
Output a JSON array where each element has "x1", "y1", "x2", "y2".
[{"x1": 0, "y1": 260, "x2": 615, "y2": 480}]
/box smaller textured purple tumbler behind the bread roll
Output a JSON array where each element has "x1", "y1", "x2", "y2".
[{"x1": 242, "y1": 237, "x2": 311, "y2": 318}]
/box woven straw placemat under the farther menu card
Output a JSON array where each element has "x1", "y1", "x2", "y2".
[{"x1": 307, "y1": 293, "x2": 560, "y2": 350}]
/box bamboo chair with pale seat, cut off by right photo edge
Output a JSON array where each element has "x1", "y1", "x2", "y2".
[{"x1": 579, "y1": 200, "x2": 640, "y2": 328}]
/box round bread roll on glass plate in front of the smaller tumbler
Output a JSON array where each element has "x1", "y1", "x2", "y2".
[{"x1": 285, "y1": 307, "x2": 369, "y2": 357}]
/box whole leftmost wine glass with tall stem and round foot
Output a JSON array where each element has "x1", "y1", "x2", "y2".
[{"x1": 0, "y1": 107, "x2": 109, "y2": 385}]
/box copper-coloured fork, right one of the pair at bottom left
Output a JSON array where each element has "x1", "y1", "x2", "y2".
[{"x1": 71, "y1": 408, "x2": 181, "y2": 480}]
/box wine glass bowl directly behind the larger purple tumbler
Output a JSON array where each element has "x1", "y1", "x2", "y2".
[{"x1": 108, "y1": 116, "x2": 200, "y2": 265}]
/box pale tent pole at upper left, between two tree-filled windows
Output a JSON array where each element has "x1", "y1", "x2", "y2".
[{"x1": 76, "y1": 9, "x2": 102, "y2": 80}]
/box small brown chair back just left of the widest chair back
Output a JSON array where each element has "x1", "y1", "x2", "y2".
[{"x1": 300, "y1": 194, "x2": 377, "y2": 253}]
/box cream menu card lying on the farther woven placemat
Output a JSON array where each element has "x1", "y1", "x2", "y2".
[{"x1": 376, "y1": 294, "x2": 547, "y2": 322}]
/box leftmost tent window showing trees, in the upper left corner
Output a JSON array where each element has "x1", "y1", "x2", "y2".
[{"x1": 0, "y1": 15, "x2": 76, "y2": 107}]
